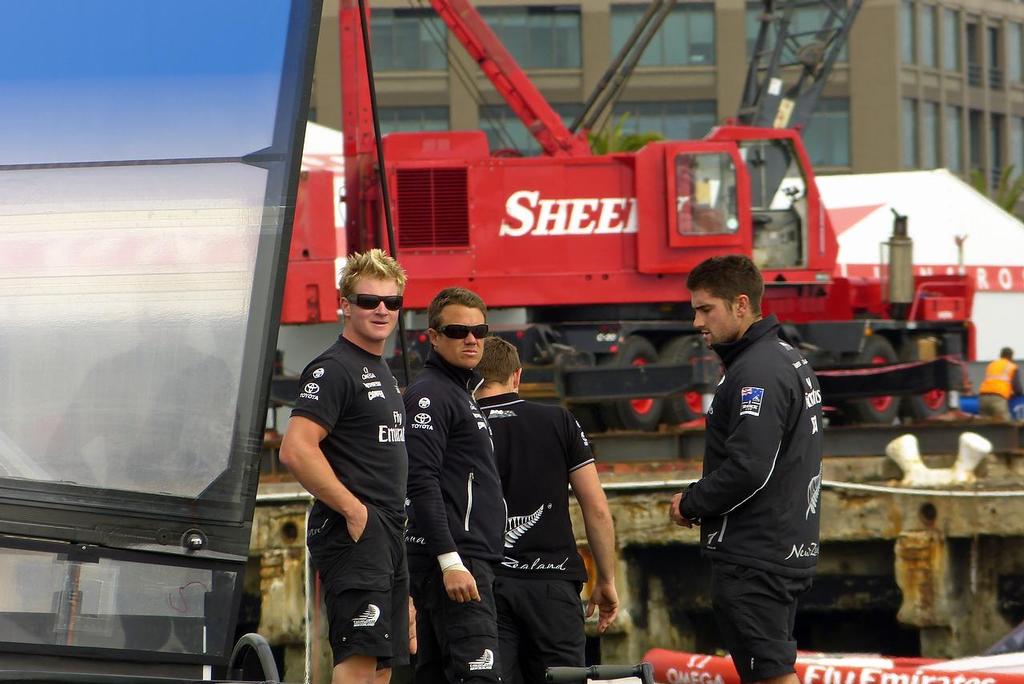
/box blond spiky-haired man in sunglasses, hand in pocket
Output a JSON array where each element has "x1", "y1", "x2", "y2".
[{"x1": 281, "y1": 249, "x2": 415, "y2": 684}]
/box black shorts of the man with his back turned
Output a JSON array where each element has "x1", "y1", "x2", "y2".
[{"x1": 495, "y1": 575, "x2": 587, "y2": 684}]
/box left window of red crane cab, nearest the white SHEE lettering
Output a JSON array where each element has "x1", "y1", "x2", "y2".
[{"x1": 675, "y1": 153, "x2": 739, "y2": 236}]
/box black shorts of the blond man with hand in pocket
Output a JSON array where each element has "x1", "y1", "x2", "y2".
[{"x1": 306, "y1": 506, "x2": 409, "y2": 668}]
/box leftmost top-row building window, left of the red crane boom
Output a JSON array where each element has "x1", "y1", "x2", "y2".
[{"x1": 370, "y1": 9, "x2": 447, "y2": 72}]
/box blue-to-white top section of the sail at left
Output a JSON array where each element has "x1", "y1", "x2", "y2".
[{"x1": 0, "y1": 0, "x2": 292, "y2": 165}]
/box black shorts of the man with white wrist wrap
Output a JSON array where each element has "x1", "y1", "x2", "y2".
[{"x1": 411, "y1": 557, "x2": 501, "y2": 684}]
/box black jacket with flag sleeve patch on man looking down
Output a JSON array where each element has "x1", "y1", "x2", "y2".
[{"x1": 680, "y1": 315, "x2": 823, "y2": 578}]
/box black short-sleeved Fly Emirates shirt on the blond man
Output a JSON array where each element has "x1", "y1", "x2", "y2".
[{"x1": 292, "y1": 337, "x2": 409, "y2": 519}]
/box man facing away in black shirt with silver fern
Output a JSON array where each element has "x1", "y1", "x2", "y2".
[{"x1": 476, "y1": 337, "x2": 618, "y2": 684}]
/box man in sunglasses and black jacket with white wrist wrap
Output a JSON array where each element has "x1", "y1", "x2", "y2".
[{"x1": 404, "y1": 288, "x2": 505, "y2": 684}]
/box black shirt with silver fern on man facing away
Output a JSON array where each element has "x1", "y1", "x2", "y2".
[{"x1": 479, "y1": 393, "x2": 594, "y2": 582}]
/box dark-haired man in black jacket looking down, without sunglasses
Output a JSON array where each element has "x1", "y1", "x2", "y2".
[{"x1": 670, "y1": 256, "x2": 822, "y2": 684}]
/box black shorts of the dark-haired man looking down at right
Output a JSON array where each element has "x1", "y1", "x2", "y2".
[{"x1": 712, "y1": 561, "x2": 811, "y2": 684}]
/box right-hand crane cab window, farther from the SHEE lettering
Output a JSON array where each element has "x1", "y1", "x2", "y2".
[{"x1": 739, "y1": 140, "x2": 807, "y2": 269}]
